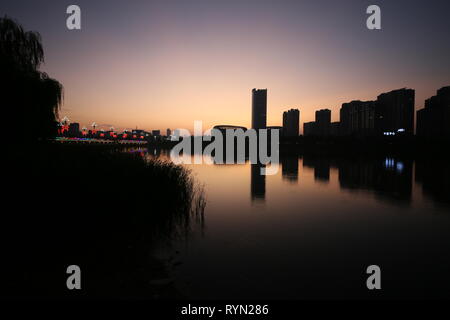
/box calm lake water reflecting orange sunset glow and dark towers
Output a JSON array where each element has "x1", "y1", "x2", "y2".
[{"x1": 144, "y1": 152, "x2": 450, "y2": 299}]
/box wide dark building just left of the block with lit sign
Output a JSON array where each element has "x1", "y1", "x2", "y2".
[{"x1": 340, "y1": 100, "x2": 376, "y2": 136}]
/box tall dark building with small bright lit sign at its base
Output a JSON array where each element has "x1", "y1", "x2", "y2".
[{"x1": 375, "y1": 88, "x2": 415, "y2": 135}]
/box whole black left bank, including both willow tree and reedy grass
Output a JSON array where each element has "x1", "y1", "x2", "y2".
[{"x1": 0, "y1": 17, "x2": 205, "y2": 298}]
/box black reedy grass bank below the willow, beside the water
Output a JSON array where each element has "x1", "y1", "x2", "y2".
[{"x1": 2, "y1": 144, "x2": 205, "y2": 298}]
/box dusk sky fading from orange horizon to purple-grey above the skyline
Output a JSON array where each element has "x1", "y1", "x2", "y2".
[{"x1": 0, "y1": 0, "x2": 450, "y2": 130}]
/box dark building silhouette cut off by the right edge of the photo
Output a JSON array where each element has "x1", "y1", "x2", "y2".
[{"x1": 416, "y1": 86, "x2": 450, "y2": 138}]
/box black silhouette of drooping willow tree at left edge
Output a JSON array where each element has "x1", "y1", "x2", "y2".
[{"x1": 0, "y1": 16, "x2": 63, "y2": 141}]
